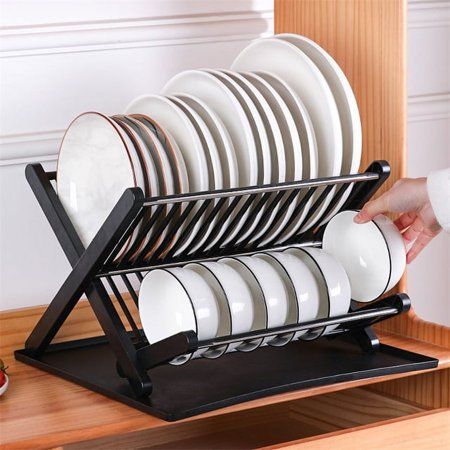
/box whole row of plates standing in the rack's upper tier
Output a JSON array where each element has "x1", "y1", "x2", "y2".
[{"x1": 57, "y1": 34, "x2": 361, "y2": 257}]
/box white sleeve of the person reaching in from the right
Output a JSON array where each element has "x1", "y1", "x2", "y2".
[{"x1": 427, "y1": 167, "x2": 450, "y2": 232}]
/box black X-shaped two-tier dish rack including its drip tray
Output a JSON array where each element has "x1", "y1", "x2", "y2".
[{"x1": 15, "y1": 161, "x2": 438, "y2": 420}]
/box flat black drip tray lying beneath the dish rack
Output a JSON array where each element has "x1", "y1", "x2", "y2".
[{"x1": 16, "y1": 337, "x2": 438, "y2": 421}]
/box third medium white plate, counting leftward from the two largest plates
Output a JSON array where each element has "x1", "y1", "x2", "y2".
[{"x1": 221, "y1": 70, "x2": 286, "y2": 243}]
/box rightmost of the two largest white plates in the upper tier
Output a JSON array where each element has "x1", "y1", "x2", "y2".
[{"x1": 276, "y1": 34, "x2": 362, "y2": 224}]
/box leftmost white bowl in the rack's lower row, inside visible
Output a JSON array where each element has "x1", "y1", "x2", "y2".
[{"x1": 139, "y1": 268, "x2": 219, "y2": 364}]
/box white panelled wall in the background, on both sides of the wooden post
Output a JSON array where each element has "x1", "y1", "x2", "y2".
[{"x1": 0, "y1": 0, "x2": 450, "y2": 324}]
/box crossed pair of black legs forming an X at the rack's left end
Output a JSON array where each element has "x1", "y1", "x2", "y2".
[{"x1": 25, "y1": 164, "x2": 152, "y2": 396}]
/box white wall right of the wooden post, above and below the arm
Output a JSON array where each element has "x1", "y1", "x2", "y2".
[{"x1": 408, "y1": 0, "x2": 450, "y2": 325}]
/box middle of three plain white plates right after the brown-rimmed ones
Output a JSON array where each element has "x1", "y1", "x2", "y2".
[{"x1": 167, "y1": 96, "x2": 223, "y2": 255}]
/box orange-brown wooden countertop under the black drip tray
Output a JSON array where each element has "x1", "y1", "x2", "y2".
[{"x1": 0, "y1": 334, "x2": 450, "y2": 449}]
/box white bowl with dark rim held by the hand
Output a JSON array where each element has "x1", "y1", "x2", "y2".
[{"x1": 322, "y1": 211, "x2": 406, "y2": 302}]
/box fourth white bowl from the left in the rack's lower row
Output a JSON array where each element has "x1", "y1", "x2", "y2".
[{"x1": 268, "y1": 252, "x2": 320, "y2": 338}]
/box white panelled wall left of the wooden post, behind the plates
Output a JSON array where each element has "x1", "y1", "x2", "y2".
[{"x1": 0, "y1": 0, "x2": 273, "y2": 310}]
